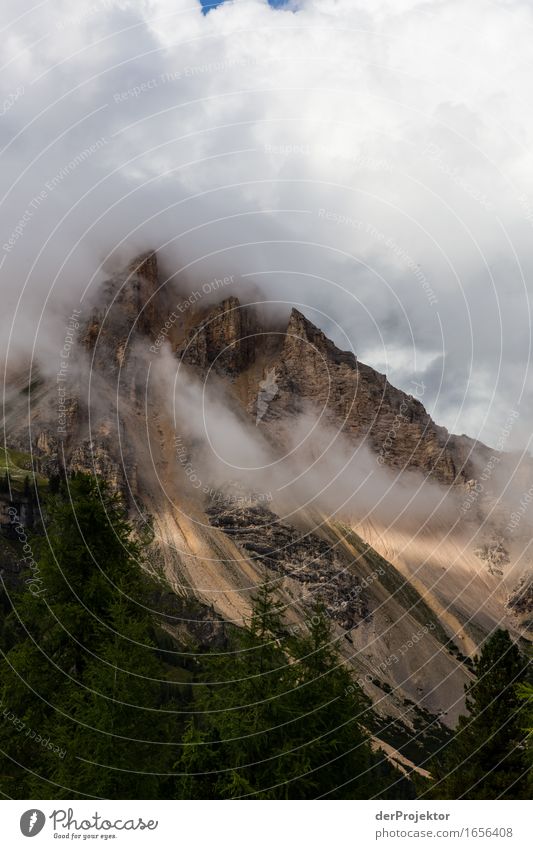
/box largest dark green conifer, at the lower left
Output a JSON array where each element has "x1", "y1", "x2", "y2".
[{"x1": 0, "y1": 476, "x2": 187, "y2": 798}]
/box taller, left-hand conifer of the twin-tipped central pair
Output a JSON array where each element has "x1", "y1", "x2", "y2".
[{"x1": 176, "y1": 583, "x2": 293, "y2": 798}]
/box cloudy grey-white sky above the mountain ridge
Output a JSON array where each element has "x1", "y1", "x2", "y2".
[{"x1": 0, "y1": 0, "x2": 533, "y2": 448}]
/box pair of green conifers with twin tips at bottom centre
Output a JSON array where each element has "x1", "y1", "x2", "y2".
[{"x1": 176, "y1": 584, "x2": 401, "y2": 799}]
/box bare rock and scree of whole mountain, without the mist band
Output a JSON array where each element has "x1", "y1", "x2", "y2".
[{"x1": 3, "y1": 253, "x2": 531, "y2": 723}]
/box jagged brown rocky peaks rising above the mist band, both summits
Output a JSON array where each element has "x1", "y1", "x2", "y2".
[{"x1": 16, "y1": 251, "x2": 488, "y2": 484}]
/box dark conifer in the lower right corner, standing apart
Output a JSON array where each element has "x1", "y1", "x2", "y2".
[{"x1": 428, "y1": 630, "x2": 528, "y2": 799}]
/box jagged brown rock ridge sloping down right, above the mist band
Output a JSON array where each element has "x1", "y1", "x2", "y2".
[{"x1": 177, "y1": 298, "x2": 490, "y2": 484}]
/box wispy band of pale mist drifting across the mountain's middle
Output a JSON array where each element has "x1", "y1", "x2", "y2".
[{"x1": 148, "y1": 346, "x2": 459, "y2": 531}]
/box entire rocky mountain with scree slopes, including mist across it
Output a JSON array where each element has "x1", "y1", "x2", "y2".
[{"x1": 0, "y1": 247, "x2": 531, "y2": 756}]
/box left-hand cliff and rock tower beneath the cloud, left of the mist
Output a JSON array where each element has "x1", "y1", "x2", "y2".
[{"x1": 2, "y1": 253, "x2": 169, "y2": 496}]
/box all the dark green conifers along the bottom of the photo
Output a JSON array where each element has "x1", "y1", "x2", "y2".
[{"x1": 0, "y1": 475, "x2": 531, "y2": 799}]
